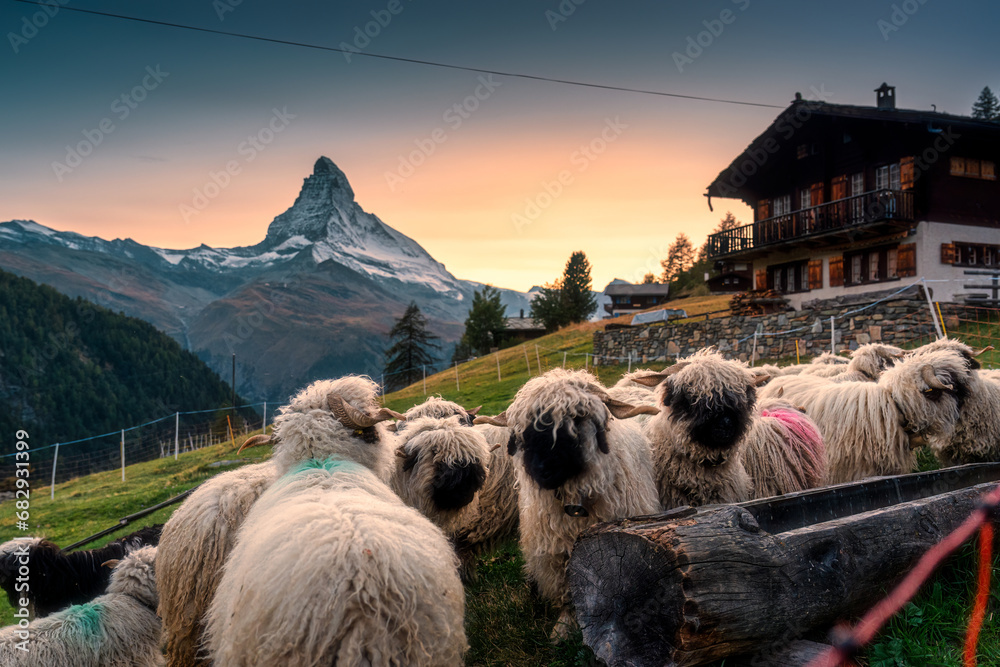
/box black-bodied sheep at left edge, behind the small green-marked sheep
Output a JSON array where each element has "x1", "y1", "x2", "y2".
[{"x1": 0, "y1": 524, "x2": 163, "y2": 618}]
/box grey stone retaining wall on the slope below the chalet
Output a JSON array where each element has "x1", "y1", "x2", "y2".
[{"x1": 594, "y1": 288, "x2": 957, "y2": 366}]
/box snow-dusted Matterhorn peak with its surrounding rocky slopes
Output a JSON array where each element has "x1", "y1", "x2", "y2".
[{"x1": 0, "y1": 157, "x2": 530, "y2": 400}]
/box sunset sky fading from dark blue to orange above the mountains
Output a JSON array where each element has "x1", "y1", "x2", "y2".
[{"x1": 0, "y1": 0, "x2": 1000, "y2": 290}]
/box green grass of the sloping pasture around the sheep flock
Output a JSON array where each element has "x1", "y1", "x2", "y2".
[{"x1": 0, "y1": 300, "x2": 1000, "y2": 667}]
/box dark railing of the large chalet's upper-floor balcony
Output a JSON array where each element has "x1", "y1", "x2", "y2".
[{"x1": 708, "y1": 190, "x2": 914, "y2": 259}]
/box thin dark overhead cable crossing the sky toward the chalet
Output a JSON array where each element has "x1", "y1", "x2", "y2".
[{"x1": 14, "y1": 0, "x2": 785, "y2": 109}]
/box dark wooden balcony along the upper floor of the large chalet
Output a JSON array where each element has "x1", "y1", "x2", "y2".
[{"x1": 708, "y1": 190, "x2": 915, "y2": 259}]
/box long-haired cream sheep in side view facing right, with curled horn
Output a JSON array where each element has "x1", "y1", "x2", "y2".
[{"x1": 761, "y1": 350, "x2": 972, "y2": 484}]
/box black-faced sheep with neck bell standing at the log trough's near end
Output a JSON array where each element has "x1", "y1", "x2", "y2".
[{"x1": 476, "y1": 368, "x2": 660, "y2": 641}]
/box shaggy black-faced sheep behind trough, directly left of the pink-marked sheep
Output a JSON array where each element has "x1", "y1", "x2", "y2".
[{"x1": 636, "y1": 348, "x2": 760, "y2": 509}]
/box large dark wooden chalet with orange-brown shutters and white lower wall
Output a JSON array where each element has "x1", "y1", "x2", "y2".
[{"x1": 707, "y1": 84, "x2": 1000, "y2": 308}]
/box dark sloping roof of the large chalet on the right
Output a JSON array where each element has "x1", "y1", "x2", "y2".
[{"x1": 706, "y1": 100, "x2": 1000, "y2": 201}]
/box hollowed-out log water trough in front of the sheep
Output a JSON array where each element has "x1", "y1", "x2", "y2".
[{"x1": 569, "y1": 463, "x2": 1000, "y2": 667}]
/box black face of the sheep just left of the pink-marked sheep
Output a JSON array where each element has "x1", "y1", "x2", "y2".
[{"x1": 663, "y1": 381, "x2": 757, "y2": 451}]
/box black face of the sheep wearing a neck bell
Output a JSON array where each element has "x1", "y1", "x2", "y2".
[{"x1": 511, "y1": 413, "x2": 596, "y2": 490}]
